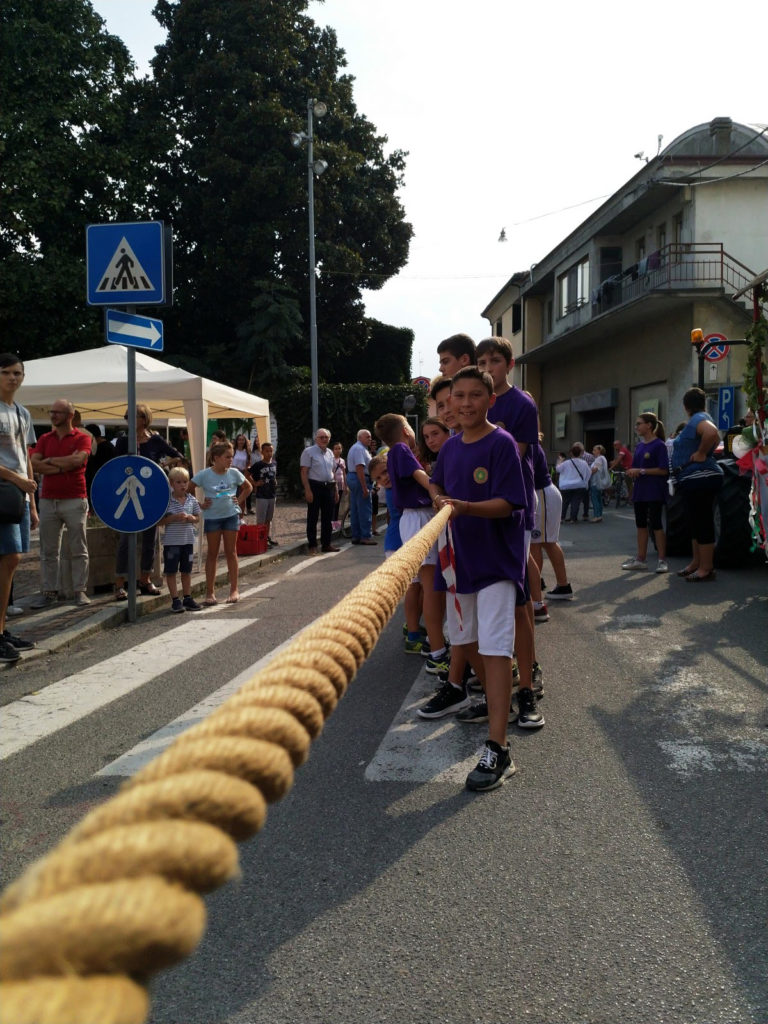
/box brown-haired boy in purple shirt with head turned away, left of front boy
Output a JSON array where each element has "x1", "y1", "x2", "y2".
[{"x1": 374, "y1": 413, "x2": 448, "y2": 675}]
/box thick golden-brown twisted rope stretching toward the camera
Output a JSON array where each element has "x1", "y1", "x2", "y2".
[{"x1": 0, "y1": 509, "x2": 450, "y2": 1024}]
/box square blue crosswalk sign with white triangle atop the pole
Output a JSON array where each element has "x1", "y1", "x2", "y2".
[{"x1": 85, "y1": 220, "x2": 169, "y2": 306}]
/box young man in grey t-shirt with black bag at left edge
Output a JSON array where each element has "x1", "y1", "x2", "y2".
[{"x1": 0, "y1": 352, "x2": 38, "y2": 663}]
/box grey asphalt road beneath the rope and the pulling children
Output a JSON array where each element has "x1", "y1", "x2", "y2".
[{"x1": 0, "y1": 510, "x2": 768, "y2": 1024}]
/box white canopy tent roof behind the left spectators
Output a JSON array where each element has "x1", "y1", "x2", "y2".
[{"x1": 18, "y1": 345, "x2": 271, "y2": 472}]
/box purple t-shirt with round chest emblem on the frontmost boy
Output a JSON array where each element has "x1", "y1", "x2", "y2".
[{"x1": 431, "y1": 429, "x2": 525, "y2": 594}]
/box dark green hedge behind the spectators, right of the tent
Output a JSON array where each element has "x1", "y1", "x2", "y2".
[{"x1": 269, "y1": 383, "x2": 427, "y2": 496}]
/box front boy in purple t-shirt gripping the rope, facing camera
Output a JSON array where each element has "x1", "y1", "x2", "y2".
[{"x1": 429, "y1": 367, "x2": 544, "y2": 791}]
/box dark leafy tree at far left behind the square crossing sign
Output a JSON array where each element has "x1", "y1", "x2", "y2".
[{"x1": 0, "y1": 0, "x2": 149, "y2": 358}]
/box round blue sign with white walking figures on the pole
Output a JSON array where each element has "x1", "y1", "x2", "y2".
[{"x1": 91, "y1": 455, "x2": 171, "y2": 534}]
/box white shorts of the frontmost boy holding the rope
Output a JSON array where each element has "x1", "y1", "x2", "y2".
[{"x1": 445, "y1": 580, "x2": 517, "y2": 657}]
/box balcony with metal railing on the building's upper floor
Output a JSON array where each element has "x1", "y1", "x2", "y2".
[{"x1": 590, "y1": 242, "x2": 755, "y2": 318}]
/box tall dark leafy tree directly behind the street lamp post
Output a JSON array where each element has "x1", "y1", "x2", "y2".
[{"x1": 153, "y1": 0, "x2": 412, "y2": 387}]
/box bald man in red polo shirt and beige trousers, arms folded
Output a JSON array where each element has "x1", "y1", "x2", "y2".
[{"x1": 30, "y1": 398, "x2": 92, "y2": 608}]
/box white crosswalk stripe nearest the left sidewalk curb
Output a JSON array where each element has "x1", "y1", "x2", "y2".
[{"x1": 0, "y1": 615, "x2": 254, "y2": 760}]
